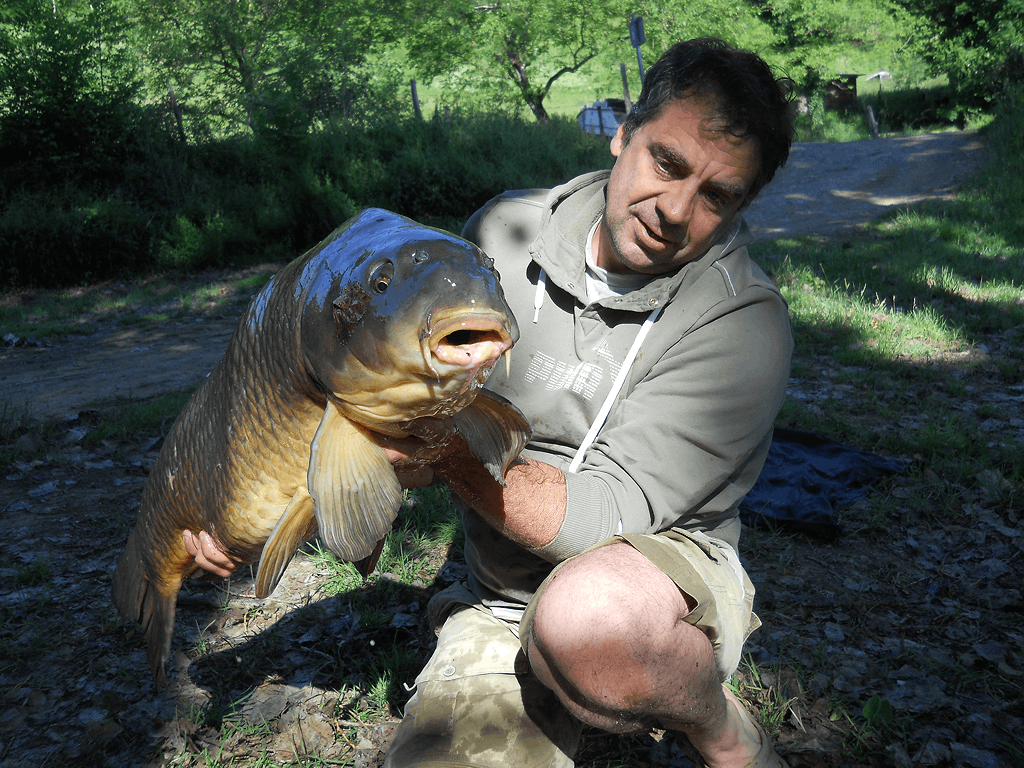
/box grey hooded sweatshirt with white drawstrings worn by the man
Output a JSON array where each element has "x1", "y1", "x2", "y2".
[{"x1": 463, "y1": 171, "x2": 793, "y2": 607}]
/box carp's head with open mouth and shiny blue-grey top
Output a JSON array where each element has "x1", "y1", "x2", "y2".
[{"x1": 301, "y1": 209, "x2": 519, "y2": 434}]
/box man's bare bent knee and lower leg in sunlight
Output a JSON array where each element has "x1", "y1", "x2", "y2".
[{"x1": 523, "y1": 542, "x2": 783, "y2": 768}]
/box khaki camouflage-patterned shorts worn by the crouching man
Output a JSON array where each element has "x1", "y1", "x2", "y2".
[{"x1": 384, "y1": 530, "x2": 760, "y2": 768}]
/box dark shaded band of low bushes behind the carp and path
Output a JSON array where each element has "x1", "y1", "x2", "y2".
[{"x1": 0, "y1": 114, "x2": 611, "y2": 287}]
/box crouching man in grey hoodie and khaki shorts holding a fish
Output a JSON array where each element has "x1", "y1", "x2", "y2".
[{"x1": 192, "y1": 39, "x2": 792, "y2": 768}]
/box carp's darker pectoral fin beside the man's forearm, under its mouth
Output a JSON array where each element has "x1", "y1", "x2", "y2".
[{"x1": 452, "y1": 389, "x2": 530, "y2": 485}]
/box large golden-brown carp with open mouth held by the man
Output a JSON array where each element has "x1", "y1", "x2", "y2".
[{"x1": 113, "y1": 209, "x2": 529, "y2": 685}]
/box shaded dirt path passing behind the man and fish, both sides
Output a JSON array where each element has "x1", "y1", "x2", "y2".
[{"x1": 0, "y1": 132, "x2": 985, "y2": 417}]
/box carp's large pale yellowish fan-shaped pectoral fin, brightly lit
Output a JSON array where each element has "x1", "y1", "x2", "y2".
[{"x1": 306, "y1": 402, "x2": 401, "y2": 562}]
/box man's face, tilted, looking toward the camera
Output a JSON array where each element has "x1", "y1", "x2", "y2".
[{"x1": 594, "y1": 99, "x2": 758, "y2": 274}]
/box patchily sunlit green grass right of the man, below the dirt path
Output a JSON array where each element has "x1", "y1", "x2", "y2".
[{"x1": 753, "y1": 88, "x2": 1024, "y2": 493}]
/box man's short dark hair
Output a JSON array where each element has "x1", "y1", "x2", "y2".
[{"x1": 623, "y1": 38, "x2": 793, "y2": 206}]
